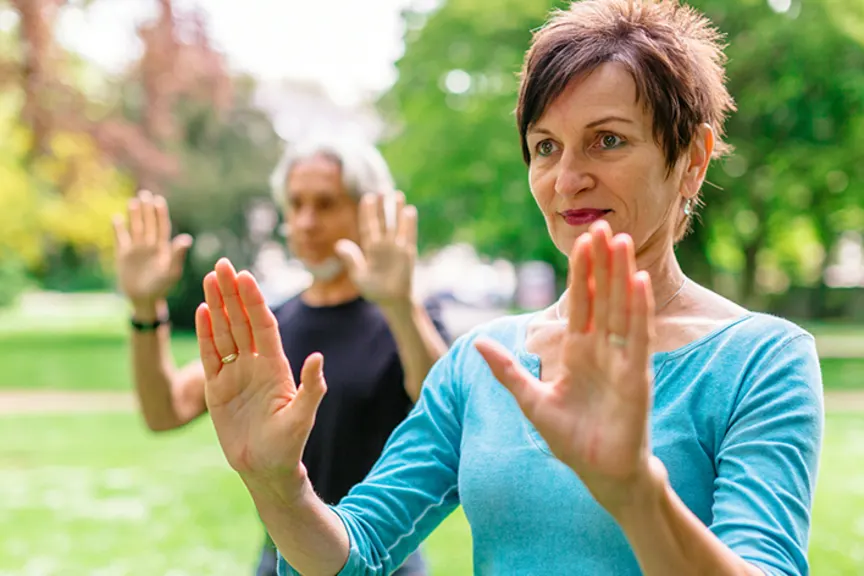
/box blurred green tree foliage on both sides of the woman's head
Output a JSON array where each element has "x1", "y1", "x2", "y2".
[{"x1": 380, "y1": 0, "x2": 864, "y2": 310}]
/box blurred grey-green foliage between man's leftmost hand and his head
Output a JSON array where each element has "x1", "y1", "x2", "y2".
[{"x1": 160, "y1": 79, "x2": 280, "y2": 329}]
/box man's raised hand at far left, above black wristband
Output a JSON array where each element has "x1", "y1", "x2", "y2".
[{"x1": 113, "y1": 190, "x2": 192, "y2": 306}]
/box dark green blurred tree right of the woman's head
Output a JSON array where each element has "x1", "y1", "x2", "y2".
[{"x1": 682, "y1": 0, "x2": 864, "y2": 306}]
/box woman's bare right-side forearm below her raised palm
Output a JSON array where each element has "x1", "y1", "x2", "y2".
[{"x1": 614, "y1": 460, "x2": 764, "y2": 576}]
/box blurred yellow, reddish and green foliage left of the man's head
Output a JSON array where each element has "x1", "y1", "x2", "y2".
[{"x1": 0, "y1": 0, "x2": 278, "y2": 316}]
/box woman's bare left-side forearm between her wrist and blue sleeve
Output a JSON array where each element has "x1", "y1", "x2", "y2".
[{"x1": 241, "y1": 475, "x2": 350, "y2": 576}]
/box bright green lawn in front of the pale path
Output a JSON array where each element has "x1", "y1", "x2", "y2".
[{"x1": 0, "y1": 414, "x2": 864, "y2": 576}]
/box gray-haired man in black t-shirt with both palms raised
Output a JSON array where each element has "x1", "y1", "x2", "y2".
[{"x1": 114, "y1": 139, "x2": 448, "y2": 576}]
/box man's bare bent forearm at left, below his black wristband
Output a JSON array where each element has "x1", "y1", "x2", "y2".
[{"x1": 131, "y1": 300, "x2": 203, "y2": 431}]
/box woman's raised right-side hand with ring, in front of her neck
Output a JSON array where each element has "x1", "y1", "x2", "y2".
[{"x1": 476, "y1": 221, "x2": 655, "y2": 515}]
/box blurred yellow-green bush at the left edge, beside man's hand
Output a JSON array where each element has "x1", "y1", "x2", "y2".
[{"x1": 0, "y1": 90, "x2": 131, "y2": 296}]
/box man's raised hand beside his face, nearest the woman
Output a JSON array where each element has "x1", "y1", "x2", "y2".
[{"x1": 336, "y1": 192, "x2": 417, "y2": 307}]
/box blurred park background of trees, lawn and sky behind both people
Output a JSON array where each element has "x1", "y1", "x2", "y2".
[{"x1": 0, "y1": 0, "x2": 864, "y2": 576}]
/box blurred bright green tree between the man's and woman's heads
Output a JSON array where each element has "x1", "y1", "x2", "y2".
[{"x1": 380, "y1": 0, "x2": 566, "y2": 282}]
